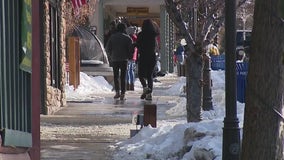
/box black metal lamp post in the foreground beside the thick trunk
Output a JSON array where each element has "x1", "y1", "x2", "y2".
[{"x1": 222, "y1": 0, "x2": 240, "y2": 160}]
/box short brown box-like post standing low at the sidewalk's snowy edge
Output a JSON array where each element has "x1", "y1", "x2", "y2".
[{"x1": 144, "y1": 104, "x2": 157, "y2": 128}]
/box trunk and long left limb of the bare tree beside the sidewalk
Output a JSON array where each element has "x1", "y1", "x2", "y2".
[{"x1": 166, "y1": 0, "x2": 204, "y2": 122}]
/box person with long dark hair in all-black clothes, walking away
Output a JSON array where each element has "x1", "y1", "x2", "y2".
[{"x1": 136, "y1": 19, "x2": 159, "y2": 100}]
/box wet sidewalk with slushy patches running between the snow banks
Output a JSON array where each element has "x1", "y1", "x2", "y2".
[{"x1": 41, "y1": 74, "x2": 178, "y2": 160}]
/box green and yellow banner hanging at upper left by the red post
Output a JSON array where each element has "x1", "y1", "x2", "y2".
[{"x1": 20, "y1": 0, "x2": 32, "y2": 73}]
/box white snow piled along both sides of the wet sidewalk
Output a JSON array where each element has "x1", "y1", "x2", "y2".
[{"x1": 66, "y1": 71, "x2": 244, "y2": 160}]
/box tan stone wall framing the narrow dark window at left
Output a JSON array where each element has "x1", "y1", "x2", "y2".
[{"x1": 44, "y1": 0, "x2": 67, "y2": 114}]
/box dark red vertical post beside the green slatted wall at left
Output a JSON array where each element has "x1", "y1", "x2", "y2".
[{"x1": 30, "y1": 0, "x2": 40, "y2": 160}]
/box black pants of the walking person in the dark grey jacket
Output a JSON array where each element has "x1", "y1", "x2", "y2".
[{"x1": 112, "y1": 61, "x2": 127, "y2": 94}]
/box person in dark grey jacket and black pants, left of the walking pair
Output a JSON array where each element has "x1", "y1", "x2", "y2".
[{"x1": 106, "y1": 23, "x2": 133, "y2": 100}]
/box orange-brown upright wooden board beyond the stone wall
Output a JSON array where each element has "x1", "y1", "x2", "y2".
[{"x1": 68, "y1": 37, "x2": 80, "y2": 89}]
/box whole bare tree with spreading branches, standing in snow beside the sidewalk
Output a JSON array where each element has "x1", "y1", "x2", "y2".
[{"x1": 165, "y1": 0, "x2": 246, "y2": 122}]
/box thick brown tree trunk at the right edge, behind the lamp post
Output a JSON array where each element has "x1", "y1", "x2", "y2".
[{"x1": 241, "y1": 0, "x2": 284, "y2": 160}]
